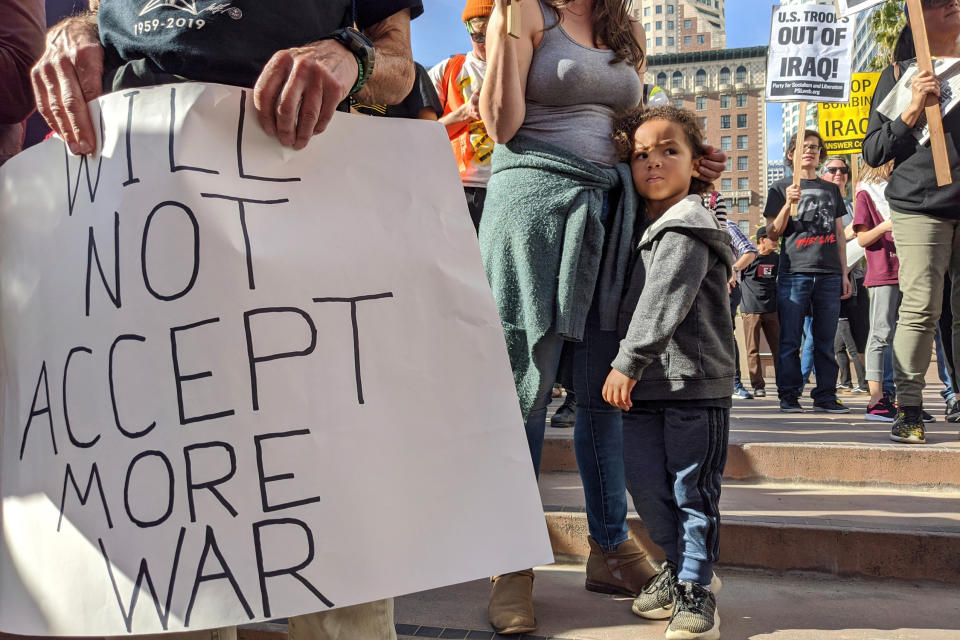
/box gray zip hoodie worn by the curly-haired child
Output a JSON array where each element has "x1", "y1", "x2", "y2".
[{"x1": 612, "y1": 195, "x2": 734, "y2": 401}]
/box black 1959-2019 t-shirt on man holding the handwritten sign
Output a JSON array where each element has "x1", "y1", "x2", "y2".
[{"x1": 99, "y1": 0, "x2": 423, "y2": 90}]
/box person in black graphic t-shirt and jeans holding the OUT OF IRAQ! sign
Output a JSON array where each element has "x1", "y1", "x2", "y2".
[{"x1": 763, "y1": 130, "x2": 850, "y2": 413}]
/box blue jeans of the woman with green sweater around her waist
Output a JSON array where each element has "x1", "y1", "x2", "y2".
[{"x1": 526, "y1": 304, "x2": 627, "y2": 552}]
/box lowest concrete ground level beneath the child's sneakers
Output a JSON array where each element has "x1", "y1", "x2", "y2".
[{"x1": 239, "y1": 564, "x2": 960, "y2": 640}]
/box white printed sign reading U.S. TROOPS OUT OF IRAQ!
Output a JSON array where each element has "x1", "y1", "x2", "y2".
[{"x1": 766, "y1": 4, "x2": 853, "y2": 102}]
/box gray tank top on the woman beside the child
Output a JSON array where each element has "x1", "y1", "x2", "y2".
[{"x1": 518, "y1": 2, "x2": 643, "y2": 166}]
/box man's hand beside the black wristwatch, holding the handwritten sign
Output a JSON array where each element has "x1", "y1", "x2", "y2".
[{"x1": 253, "y1": 40, "x2": 359, "y2": 149}]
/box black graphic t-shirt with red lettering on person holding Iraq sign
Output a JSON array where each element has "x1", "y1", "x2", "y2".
[{"x1": 763, "y1": 178, "x2": 847, "y2": 274}]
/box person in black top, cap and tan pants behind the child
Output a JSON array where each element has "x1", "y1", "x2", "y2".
[{"x1": 740, "y1": 227, "x2": 780, "y2": 397}]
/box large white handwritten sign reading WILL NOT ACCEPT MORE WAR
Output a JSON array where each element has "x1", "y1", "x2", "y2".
[{"x1": 0, "y1": 84, "x2": 552, "y2": 636}]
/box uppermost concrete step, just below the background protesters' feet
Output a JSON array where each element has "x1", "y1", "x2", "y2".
[{"x1": 540, "y1": 393, "x2": 960, "y2": 489}]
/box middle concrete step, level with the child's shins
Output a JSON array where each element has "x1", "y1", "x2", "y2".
[{"x1": 540, "y1": 472, "x2": 960, "y2": 584}]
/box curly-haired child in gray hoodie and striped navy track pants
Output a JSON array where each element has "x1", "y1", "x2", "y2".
[{"x1": 603, "y1": 107, "x2": 734, "y2": 639}]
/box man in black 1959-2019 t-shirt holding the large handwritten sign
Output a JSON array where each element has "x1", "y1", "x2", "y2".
[{"x1": 32, "y1": 0, "x2": 423, "y2": 154}]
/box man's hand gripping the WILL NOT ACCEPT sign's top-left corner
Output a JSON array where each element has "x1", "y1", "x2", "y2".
[{"x1": 30, "y1": 16, "x2": 103, "y2": 154}]
